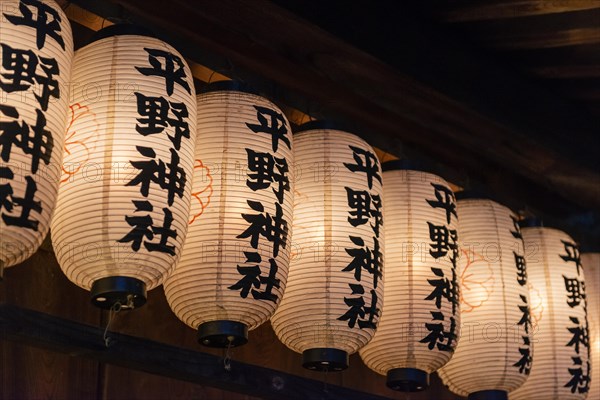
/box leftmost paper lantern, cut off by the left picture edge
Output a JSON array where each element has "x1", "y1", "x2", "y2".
[{"x1": 0, "y1": 0, "x2": 73, "y2": 278}]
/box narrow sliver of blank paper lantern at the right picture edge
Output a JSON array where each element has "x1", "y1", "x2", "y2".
[{"x1": 581, "y1": 253, "x2": 600, "y2": 399}]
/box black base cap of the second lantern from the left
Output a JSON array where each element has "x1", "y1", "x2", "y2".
[{"x1": 91, "y1": 276, "x2": 146, "y2": 310}]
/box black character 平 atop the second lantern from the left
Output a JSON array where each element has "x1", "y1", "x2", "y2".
[{"x1": 135, "y1": 47, "x2": 192, "y2": 96}]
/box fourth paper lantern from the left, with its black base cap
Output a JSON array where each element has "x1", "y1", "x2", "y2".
[{"x1": 271, "y1": 122, "x2": 383, "y2": 371}]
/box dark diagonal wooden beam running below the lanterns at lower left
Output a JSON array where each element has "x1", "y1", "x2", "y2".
[{"x1": 0, "y1": 304, "x2": 388, "y2": 400}]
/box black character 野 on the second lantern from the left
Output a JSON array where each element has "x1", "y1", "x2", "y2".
[{"x1": 134, "y1": 92, "x2": 190, "y2": 150}]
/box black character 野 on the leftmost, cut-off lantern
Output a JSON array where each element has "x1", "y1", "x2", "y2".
[{"x1": 0, "y1": 44, "x2": 60, "y2": 111}]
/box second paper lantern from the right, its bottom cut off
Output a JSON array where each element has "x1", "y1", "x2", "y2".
[{"x1": 510, "y1": 221, "x2": 590, "y2": 400}]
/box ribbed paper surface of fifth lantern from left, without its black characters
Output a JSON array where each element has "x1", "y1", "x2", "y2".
[{"x1": 360, "y1": 170, "x2": 460, "y2": 375}]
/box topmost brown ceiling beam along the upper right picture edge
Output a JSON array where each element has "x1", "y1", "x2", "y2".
[{"x1": 442, "y1": 0, "x2": 600, "y2": 22}]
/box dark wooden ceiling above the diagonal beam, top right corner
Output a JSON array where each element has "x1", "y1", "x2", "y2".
[{"x1": 421, "y1": 0, "x2": 600, "y2": 119}]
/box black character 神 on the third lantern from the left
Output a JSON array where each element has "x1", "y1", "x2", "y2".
[{"x1": 237, "y1": 200, "x2": 288, "y2": 257}]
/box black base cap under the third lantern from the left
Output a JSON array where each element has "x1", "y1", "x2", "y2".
[{"x1": 198, "y1": 320, "x2": 248, "y2": 348}]
